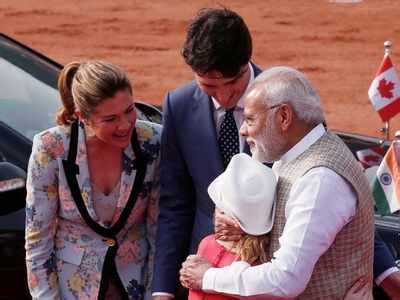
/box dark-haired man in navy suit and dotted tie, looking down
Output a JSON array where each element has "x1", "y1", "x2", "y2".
[{"x1": 153, "y1": 8, "x2": 261, "y2": 299}]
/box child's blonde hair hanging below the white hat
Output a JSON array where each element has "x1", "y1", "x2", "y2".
[{"x1": 237, "y1": 233, "x2": 270, "y2": 265}]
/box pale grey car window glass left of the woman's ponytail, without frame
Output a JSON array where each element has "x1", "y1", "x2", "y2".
[{"x1": 0, "y1": 57, "x2": 60, "y2": 139}]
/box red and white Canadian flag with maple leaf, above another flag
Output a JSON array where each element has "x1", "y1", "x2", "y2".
[{"x1": 368, "y1": 54, "x2": 400, "y2": 122}]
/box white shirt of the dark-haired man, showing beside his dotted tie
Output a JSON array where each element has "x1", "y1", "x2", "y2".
[{"x1": 211, "y1": 63, "x2": 254, "y2": 152}]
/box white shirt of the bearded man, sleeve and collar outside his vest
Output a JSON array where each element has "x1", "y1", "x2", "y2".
[{"x1": 202, "y1": 124, "x2": 357, "y2": 299}]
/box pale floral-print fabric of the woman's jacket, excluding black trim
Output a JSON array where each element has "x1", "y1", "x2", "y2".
[{"x1": 25, "y1": 121, "x2": 161, "y2": 299}]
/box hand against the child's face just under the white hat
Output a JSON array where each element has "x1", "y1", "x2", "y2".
[{"x1": 214, "y1": 208, "x2": 244, "y2": 242}]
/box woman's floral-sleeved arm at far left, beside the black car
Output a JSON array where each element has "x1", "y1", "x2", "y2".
[{"x1": 25, "y1": 132, "x2": 59, "y2": 299}]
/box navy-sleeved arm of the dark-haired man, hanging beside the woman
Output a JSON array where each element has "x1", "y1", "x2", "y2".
[{"x1": 153, "y1": 95, "x2": 194, "y2": 295}]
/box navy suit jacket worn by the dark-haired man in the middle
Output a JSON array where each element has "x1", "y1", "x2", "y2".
[{"x1": 153, "y1": 65, "x2": 261, "y2": 294}]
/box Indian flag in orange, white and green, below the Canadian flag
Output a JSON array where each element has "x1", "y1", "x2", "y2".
[{"x1": 372, "y1": 142, "x2": 400, "y2": 215}]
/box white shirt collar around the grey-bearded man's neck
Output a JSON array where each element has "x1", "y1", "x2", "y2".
[{"x1": 272, "y1": 123, "x2": 326, "y2": 176}]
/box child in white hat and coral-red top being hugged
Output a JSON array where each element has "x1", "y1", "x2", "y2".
[{"x1": 188, "y1": 153, "x2": 276, "y2": 300}]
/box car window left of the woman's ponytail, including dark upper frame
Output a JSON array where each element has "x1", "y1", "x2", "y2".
[{"x1": 0, "y1": 34, "x2": 61, "y2": 140}]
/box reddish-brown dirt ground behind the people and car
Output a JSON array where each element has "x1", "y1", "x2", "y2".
[{"x1": 0, "y1": 0, "x2": 400, "y2": 136}]
